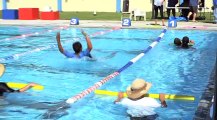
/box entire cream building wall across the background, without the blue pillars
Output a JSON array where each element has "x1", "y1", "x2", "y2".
[{"x1": 0, "y1": 0, "x2": 213, "y2": 12}]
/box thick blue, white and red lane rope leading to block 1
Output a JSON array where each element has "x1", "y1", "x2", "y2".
[{"x1": 65, "y1": 27, "x2": 167, "y2": 104}]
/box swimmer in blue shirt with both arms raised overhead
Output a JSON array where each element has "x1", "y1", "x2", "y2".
[{"x1": 56, "y1": 30, "x2": 92, "y2": 58}]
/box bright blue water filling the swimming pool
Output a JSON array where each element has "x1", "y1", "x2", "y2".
[{"x1": 0, "y1": 26, "x2": 217, "y2": 120}]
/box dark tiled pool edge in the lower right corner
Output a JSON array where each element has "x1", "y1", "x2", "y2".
[{"x1": 193, "y1": 63, "x2": 217, "y2": 120}]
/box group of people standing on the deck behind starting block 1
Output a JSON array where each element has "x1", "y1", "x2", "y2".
[{"x1": 154, "y1": 0, "x2": 217, "y2": 26}]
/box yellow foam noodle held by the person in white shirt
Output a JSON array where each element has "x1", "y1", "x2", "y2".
[{"x1": 94, "y1": 90, "x2": 195, "y2": 101}]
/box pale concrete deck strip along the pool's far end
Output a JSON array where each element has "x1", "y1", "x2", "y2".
[{"x1": 0, "y1": 19, "x2": 217, "y2": 30}]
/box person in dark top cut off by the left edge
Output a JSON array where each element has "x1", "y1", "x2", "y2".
[{"x1": 0, "y1": 64, "x2": 38, "y2": 97}]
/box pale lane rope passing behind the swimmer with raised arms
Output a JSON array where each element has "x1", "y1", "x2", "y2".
[{"x1": 0, "y1": 27, "x2": 121, "y2": 62}]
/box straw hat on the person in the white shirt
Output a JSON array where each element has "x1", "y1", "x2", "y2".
[{"x1": 126, "y1": 79, "x2": 151, "y2": 99}]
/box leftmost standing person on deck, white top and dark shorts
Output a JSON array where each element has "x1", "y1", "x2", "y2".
[{"x1": 154, "y1": 0, "x2": 165, "y2": 26}]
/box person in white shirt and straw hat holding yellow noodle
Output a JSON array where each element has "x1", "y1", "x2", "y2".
[{"x1": 114, "y1": 79, "x2": 167, "y2": 119}]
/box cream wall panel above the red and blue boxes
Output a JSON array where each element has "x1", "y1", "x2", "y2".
[{"x1": 7, "y1": 0, "x2": 57, "y2": 11}]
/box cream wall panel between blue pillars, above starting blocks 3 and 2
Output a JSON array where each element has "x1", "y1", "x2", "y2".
[{"x1": 62, "y1": 0, "x2": 116, "y2": 12}]
